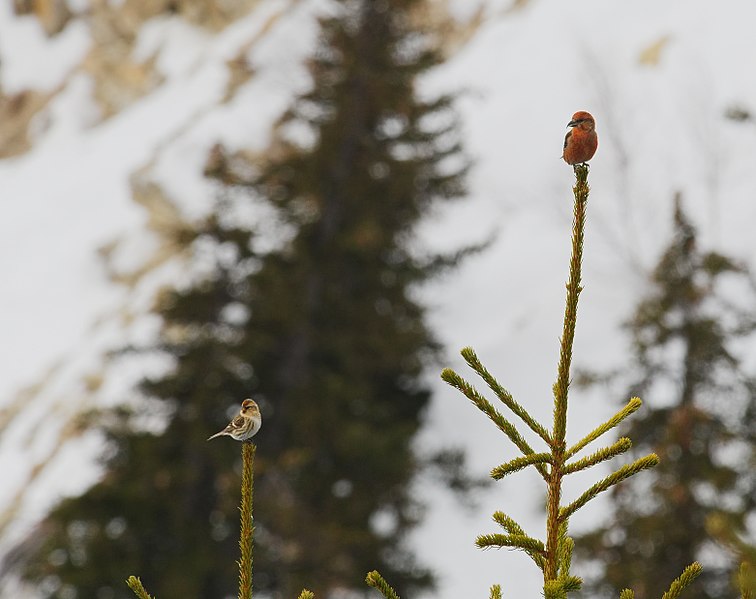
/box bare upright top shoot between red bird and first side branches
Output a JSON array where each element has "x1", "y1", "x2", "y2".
[{"x1": 551, "y1": 165, "x2": 590, "y2": 451}]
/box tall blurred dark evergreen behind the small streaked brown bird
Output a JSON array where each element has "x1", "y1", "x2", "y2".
[{"x1": 14, "y1": 0, "x2": 466, "y2": 599}]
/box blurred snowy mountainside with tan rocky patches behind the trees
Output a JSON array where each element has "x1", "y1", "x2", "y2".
[{"x1": 0, "y1": 0, "x2": 756, "y2": 599}]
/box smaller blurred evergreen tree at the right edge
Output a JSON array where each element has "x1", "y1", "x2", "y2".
[{"x1": 576, "y1": 197, "x2": 756, "y2": 599}]
